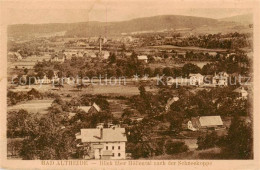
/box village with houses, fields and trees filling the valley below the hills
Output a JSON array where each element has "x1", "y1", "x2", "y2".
[{"x1": 7, "y1": 14, "x2": 253, "y2": 160}]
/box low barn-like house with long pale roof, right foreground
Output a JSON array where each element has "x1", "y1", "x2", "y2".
[{"x1": 188, "y1": 116, "x2": 223, "y2": 131}]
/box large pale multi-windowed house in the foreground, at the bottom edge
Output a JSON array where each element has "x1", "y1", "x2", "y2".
[{"x1": 76, "y1": 125, "x2": 127, "y2": 159}]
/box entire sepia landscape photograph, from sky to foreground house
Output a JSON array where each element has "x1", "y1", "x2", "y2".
[{"x1": 1, "y1": 0, "x2": 257, "y2": 167}]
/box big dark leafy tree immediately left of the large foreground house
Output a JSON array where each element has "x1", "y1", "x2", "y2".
[{"x1": 20, "y1": 114, "x2": 76, "y2": 160}]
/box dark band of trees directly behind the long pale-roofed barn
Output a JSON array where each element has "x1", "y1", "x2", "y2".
[{"x1": 170, "y1": 87, "x2": 250, "y2": 118}]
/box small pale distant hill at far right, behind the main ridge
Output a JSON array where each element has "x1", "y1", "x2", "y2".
[{"x1": 219, "y1": 14, "x2": 253, "y2": 25}]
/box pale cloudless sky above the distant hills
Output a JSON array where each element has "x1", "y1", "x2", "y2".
[{"x1": 3, "y1": 0, "x2": 252, "y2": 24}]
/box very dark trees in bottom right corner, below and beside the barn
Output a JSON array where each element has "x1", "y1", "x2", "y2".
[{"x1": 197, "y1": 116, "x2": 253, "y2": 159}]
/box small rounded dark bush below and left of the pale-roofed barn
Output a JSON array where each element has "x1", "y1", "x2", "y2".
[{"x1": 165, "y1": 140, "x2": 188, "y2": 155}]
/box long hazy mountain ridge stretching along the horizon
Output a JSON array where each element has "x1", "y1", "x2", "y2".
[{"x1": 8, "y1": 15, "x2": 252, "y2": 36}]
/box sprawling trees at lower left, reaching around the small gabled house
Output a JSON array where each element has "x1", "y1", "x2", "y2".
[{"x1": 7, "y1": 92, "x2": 114, "y2": 159}]
